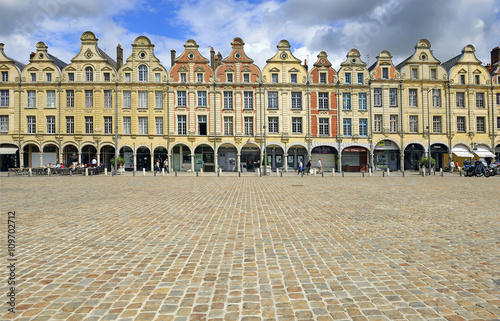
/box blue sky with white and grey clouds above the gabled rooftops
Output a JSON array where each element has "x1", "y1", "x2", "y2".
[{"x1": 0, "y1": 0, "x2": 500, "y2": 69}]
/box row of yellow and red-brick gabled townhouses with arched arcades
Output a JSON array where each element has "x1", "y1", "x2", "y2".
[{"x1": 0, "y1": 31, "x2": 500, "y2": 171}]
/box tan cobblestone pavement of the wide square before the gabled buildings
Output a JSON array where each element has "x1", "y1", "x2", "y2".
[{"x1": 0, "y1": 176, "x2": 500, "y2": 321}]
